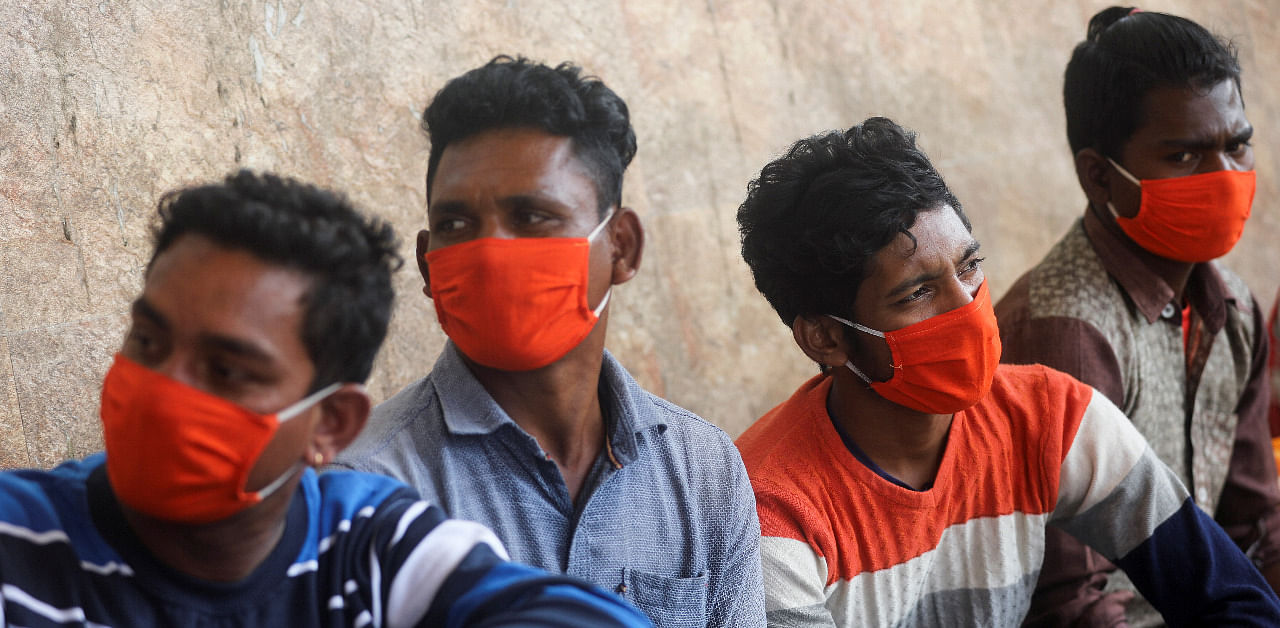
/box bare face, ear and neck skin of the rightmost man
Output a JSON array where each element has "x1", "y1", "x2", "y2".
[{"x1": 1075, "y1": 79, "x2": 1253, "y2": 299}]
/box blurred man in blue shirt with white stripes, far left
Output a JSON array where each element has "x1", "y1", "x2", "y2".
[{"x1": 0, "y1": 171, "x2": 649, "y2": 627}]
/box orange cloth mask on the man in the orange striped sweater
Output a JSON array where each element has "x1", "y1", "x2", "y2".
[{"x1": 832, "y1": 279, "x2": 1001, "y2": 414}]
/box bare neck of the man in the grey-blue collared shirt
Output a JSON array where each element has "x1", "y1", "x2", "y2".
[{"x1": 463, "y1": 318, "x2": 605, "y2": 499}]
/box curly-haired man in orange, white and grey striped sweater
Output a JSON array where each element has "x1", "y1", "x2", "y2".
[{"x1": 737, "y1": 118, "x2": 1280, "y2": 625}]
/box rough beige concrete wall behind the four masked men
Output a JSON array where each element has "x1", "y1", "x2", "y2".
[{"x1": 0, "y1": 0, "x2": 1280, "y2": 467}]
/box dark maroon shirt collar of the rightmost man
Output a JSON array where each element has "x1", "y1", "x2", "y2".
[{"x1": 1083, "y1": 211, "x2": 1236, "y2": 334}]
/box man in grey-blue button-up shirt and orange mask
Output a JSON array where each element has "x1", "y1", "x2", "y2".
[{"x1": 339, "y1": 58, "x2": 764, "y2": 627}]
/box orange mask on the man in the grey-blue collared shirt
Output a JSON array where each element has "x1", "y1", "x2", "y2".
[{"x1": 425, "y1": 212, "x2": 613, "y2": 371}]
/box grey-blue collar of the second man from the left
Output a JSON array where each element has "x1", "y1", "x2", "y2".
[{"x1": 431, "y1": 340, "x2": 666, "y2": 464}]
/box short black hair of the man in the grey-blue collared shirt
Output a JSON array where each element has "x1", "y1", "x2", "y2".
[{"x1": 422, "y1": 55, "x2": 636, "y2": 215}]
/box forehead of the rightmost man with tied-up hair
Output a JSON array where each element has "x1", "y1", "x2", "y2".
[{"x1": 1130, "y1": 79, "x2": 1249, "y2": 142}]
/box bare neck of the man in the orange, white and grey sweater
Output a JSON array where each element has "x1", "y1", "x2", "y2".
[{"x1": 827, "y1": 367, "x2": 952, "y2": 489}]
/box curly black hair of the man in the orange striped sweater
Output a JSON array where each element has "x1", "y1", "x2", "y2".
[{"x1": 737, "y1": 118, "x2": 972, "y2": 326}]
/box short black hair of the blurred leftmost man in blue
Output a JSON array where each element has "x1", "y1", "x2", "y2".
[{"x1": 147, "y1": 170, "x2": 403, "y2": 390}]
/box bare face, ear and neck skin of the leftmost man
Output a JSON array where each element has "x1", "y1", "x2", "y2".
[{"x1": 119, "y1": 235, "x2": 370, "y2": 582}]
